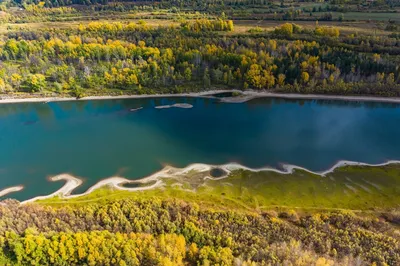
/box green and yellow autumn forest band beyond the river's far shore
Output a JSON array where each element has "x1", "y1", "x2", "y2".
[{"x1": 0, "y1": 19, "x2": 400, "y2": 97}]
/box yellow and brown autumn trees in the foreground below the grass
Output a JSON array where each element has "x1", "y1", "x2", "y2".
[{"x1": 0, "y1": 197, "x2": 400, "y2": 265}]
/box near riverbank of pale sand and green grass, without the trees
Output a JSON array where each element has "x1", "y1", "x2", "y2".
[{"x1": 3, "y1": 161, "x2": 400, "y2": 210}]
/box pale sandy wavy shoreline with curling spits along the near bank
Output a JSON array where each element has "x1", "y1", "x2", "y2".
[{"x1": 0, "y1": 160, "x2": 400, "y2": 204}]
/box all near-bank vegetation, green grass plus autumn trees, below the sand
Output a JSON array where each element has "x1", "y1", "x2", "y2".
[{"x1": 0, "y1": 165, "x2": 400, "y2": 265}]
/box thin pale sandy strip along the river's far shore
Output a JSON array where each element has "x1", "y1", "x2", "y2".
[{"x1": 0, "y1": 90, "x2": 400, "y2": 104}]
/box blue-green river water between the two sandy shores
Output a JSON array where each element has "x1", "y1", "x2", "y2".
[{"x1": 0, "y1": 98, "x2": 400, "y2": 200}]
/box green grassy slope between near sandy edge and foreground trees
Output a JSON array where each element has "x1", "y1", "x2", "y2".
[{"x1": 40, "y1": 165, "x2": 400, "y2": 212}]
